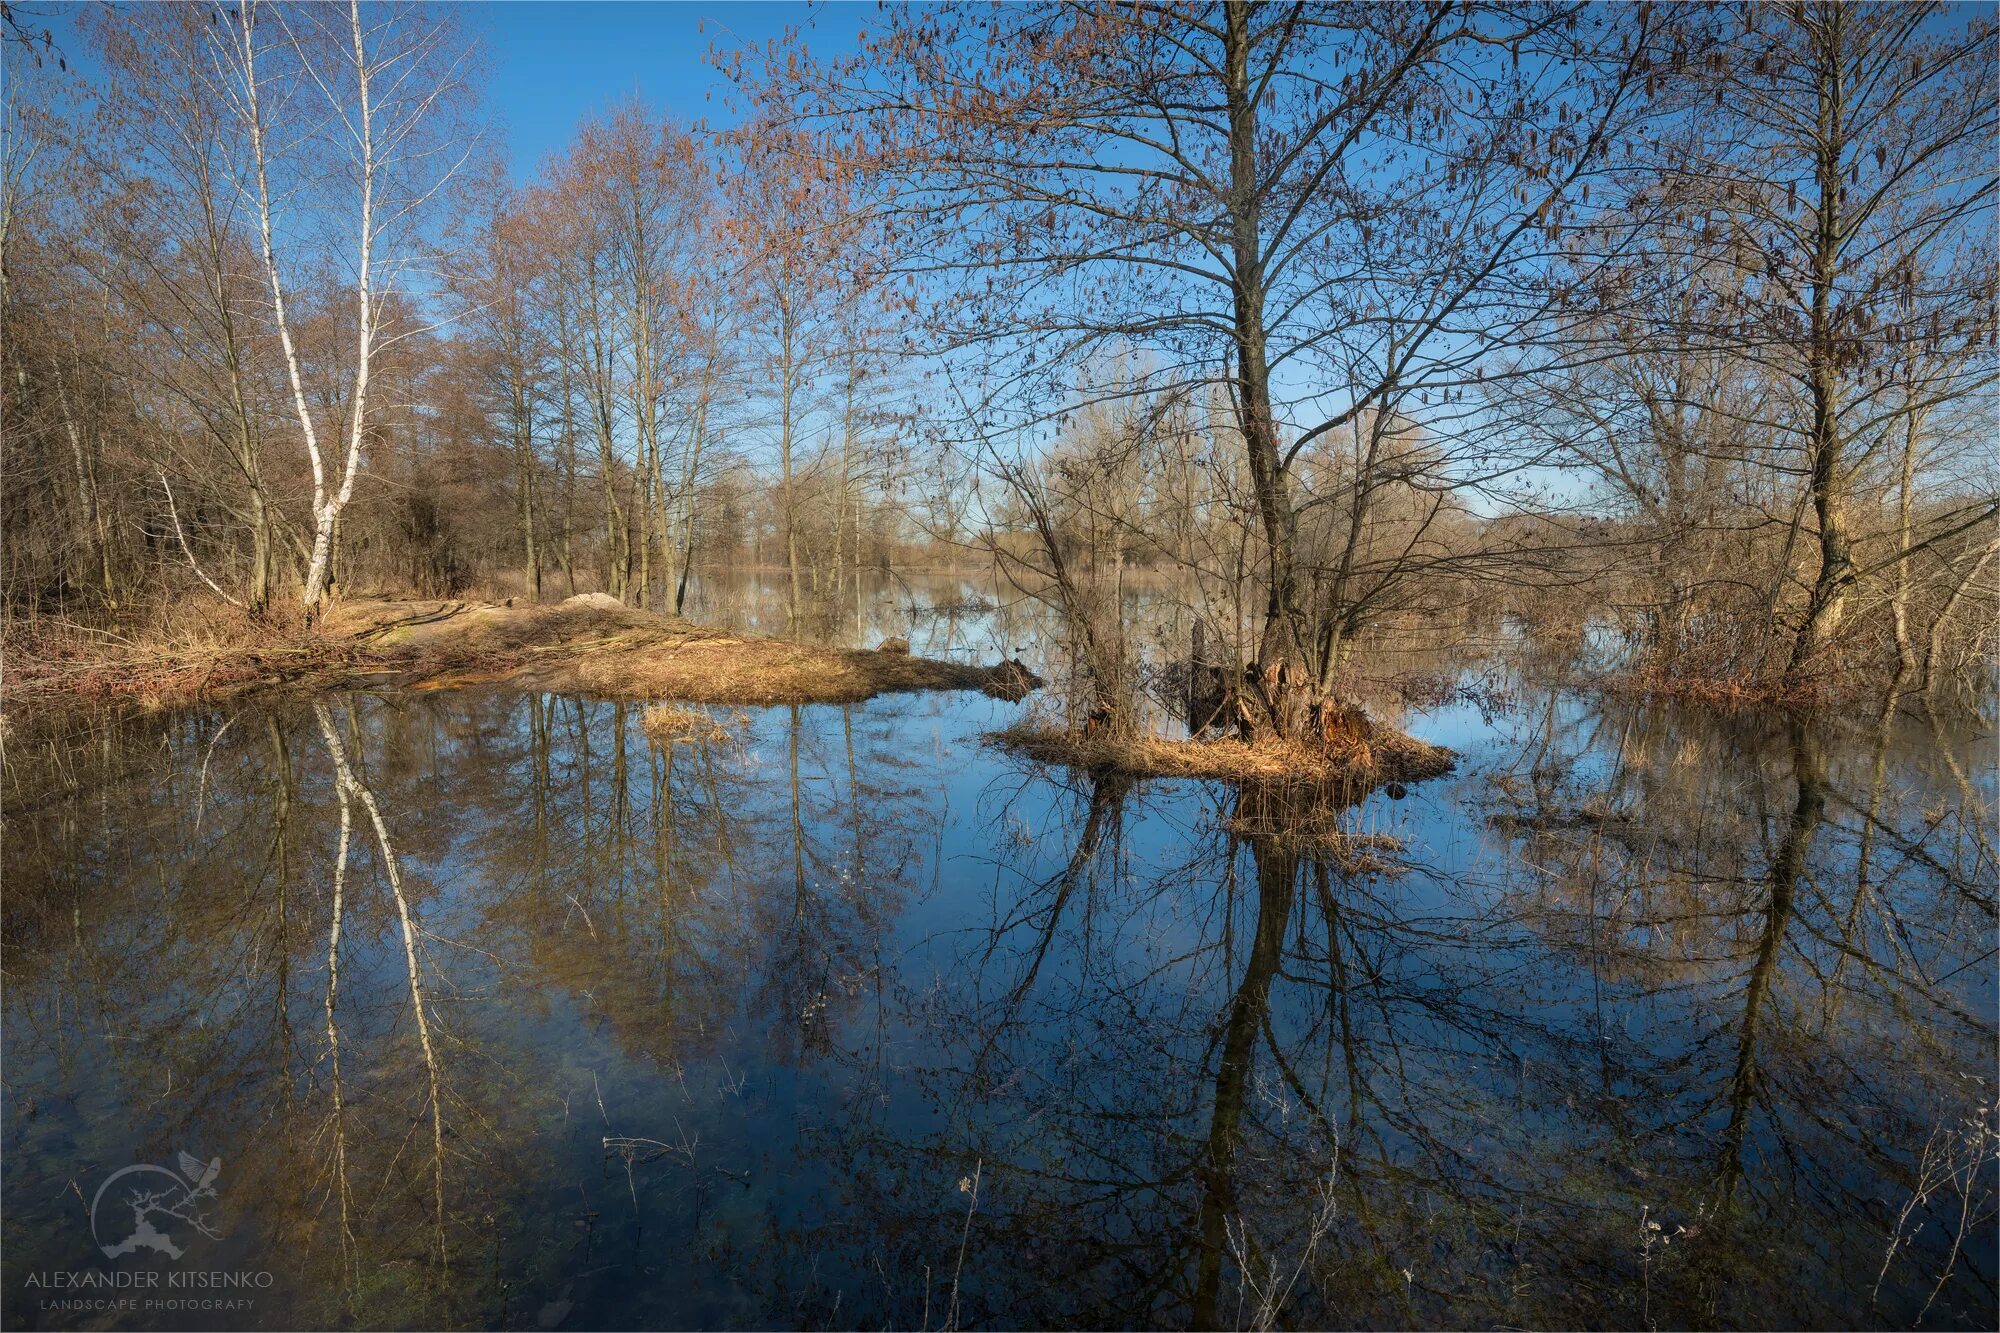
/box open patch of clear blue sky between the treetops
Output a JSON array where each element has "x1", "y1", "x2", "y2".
[{"x1": 480, "y1": 0, "x2": 876, "y2": 180}]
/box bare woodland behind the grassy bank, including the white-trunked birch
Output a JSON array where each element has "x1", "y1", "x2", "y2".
[{"x1": 0, "y1": 0, "x2": 928, "y2": 622}]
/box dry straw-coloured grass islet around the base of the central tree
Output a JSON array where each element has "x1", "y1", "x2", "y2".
[{"x1": 992, "y1": 723, "x2": 1452, "y2": 791}]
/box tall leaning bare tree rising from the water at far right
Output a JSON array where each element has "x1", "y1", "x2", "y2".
[{"x1": 1670, "y1": 4, "x2": 2000, "y2": 683}]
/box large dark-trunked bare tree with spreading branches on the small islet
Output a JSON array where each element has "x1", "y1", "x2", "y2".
[{"x1": 770, "y1": 2, "x2": 1652, "y2": 729}]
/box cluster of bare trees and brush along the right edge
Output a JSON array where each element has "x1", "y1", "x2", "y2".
[{"x1": 1508, "y1": 6, "x2": 1996, "y2": 685}]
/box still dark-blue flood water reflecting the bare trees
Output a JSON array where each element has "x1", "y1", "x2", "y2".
[{"x1": 4, "y1": 588, "x2": 1996, "y2": 1329}]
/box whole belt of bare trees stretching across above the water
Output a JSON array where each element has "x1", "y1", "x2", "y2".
[{"x1": 0, "y1": 0, "x2": 2000, "y2": 735}]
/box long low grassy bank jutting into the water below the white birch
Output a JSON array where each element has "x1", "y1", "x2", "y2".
[{"x1": 0, "y1": 594, "x2": 1040, "y2": 711}]
